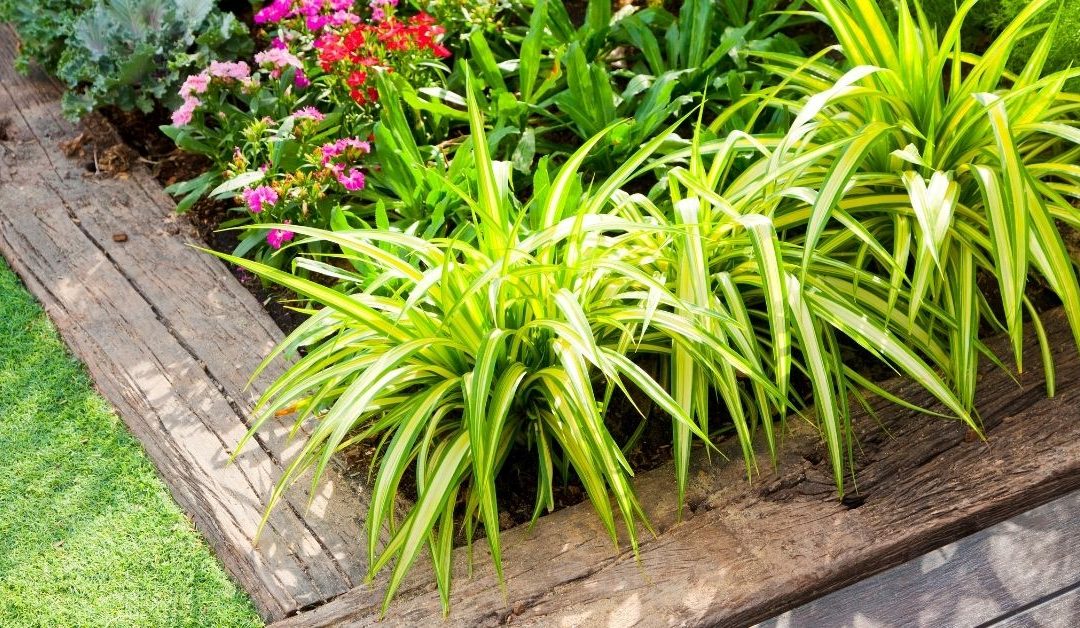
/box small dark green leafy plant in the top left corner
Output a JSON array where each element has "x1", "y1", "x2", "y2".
[{"x1": 0, "y1": 0, "x2": 93, "y2": 72}]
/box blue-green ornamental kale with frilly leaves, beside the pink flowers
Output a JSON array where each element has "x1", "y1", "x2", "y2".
[{"x1": 56, "y1": 0, "x2": 252, "y2": 118}]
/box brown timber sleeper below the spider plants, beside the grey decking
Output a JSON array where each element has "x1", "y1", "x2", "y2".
[{"x1": 280, "y1": 302, "x2": 1080, "y2": 627}]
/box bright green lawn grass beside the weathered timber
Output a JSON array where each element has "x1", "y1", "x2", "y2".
[{"x1": 0, "y1": 260, "x2": 261, "y2": 628}]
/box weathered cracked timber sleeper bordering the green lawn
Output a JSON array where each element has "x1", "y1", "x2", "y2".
[{"x1": 0, "y1": 26, "x2": 384, "y2": 619}]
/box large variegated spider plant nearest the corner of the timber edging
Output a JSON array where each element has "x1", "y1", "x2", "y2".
[{"x1": 209, "y1": 77, "x2": 738, "y2": 611}]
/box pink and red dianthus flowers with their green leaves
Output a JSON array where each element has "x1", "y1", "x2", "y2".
[{"x1": 173, "y1": 0, "x2": 450, "y2": 259}]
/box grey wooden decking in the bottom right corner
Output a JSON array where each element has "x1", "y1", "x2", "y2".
[{"x1": 758, "y1": 492, "x2": 1080, "y2": 628}]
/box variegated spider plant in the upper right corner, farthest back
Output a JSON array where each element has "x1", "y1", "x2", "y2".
[{"x1": 761, "y1": 0, "x2": 1080, "y2": 410}]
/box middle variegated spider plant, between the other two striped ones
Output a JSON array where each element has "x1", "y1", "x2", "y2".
[{"x1": 618, "y1": 102, "x2": 978, "y2": 496}]
